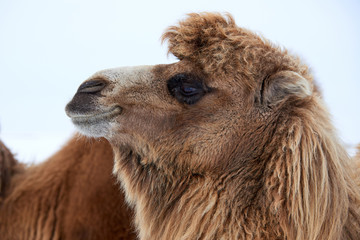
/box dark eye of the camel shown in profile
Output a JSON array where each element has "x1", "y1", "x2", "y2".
[{"x1": 167, "y1": 73, "x2": 207, "y2": 105}]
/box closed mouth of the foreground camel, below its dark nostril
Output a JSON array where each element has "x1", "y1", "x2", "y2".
[{"x1": 67, "y1": 106, "x2": 122, "y2": 125}]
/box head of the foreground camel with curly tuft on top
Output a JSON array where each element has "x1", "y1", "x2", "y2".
[{"x1": 66, "y1": 15, "x2": 313, "y2": 173}]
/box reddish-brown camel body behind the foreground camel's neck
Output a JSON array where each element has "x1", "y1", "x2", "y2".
[{"x1": 0, "y1": 135, "x2": 136, "y2": 240}]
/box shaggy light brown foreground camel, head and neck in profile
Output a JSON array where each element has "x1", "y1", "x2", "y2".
[{"x1": 67, "y1": 13, "x2": 360, "y2": 240}]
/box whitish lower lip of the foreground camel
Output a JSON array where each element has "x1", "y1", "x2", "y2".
[{"x1": 71, "y1": 106, "x2": 122, "y2": 124}]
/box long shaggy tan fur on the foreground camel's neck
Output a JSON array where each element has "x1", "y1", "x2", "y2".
[{"x1": 114, "y1": 96, "x2": 360, "y2": 240}]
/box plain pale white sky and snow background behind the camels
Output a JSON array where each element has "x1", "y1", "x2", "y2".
[{"x1": 0, "y1": 0, "x2": 360, "y2": 162}]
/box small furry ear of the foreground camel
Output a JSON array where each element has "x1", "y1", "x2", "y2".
[{"x1": 261, "y1": 71, "x2": 313, "y2": 107}]
